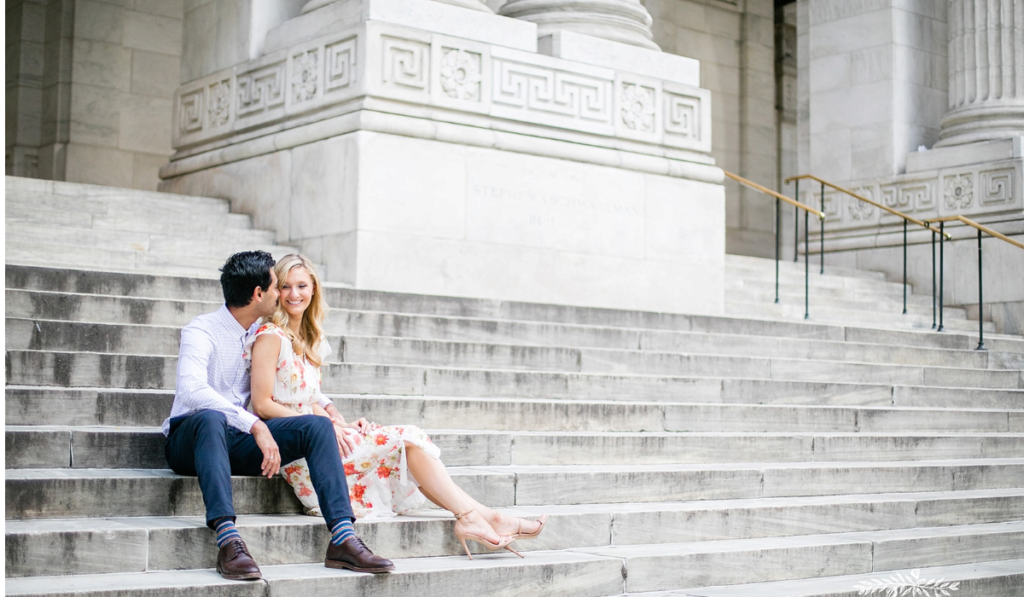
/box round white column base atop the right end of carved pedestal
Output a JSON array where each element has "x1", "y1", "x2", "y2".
[{"x1": 499, "y1": 0, "x2": 660, "y2": 51}]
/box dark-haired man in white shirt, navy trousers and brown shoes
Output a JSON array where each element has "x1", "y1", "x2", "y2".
[{"x1": 164, "y1": 251, "x2": 394, "y2": 580}]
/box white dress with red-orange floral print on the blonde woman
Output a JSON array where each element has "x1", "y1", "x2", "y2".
[{"x1": 243, "y1": 323, "x2": 440, "y2": 518}]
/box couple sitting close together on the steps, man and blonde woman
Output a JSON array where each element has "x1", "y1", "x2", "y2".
[{"x1": 164, "y1": 251, "x2": 547, "y2": 580}]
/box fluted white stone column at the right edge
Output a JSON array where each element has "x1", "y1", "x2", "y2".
[{"x1": 936, "y1": 0, "x2": 1024, "y2": 146}]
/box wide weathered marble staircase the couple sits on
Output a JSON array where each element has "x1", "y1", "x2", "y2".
[{"x1": 5, "y1": 178, "x2": 1024, "y2": 597}]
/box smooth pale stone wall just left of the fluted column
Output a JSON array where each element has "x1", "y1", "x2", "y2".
[{"x1": 798, "y1": 0, "x2": 947, "y2": 181}]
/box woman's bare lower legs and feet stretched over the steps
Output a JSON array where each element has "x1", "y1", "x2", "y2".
[{"x1": 406, "y1": 443, "x2": 540, "y2": 543}]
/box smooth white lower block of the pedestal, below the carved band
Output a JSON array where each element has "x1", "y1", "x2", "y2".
[{"x1": 162, "y1": 131, "x2": 725, "y2": 314}]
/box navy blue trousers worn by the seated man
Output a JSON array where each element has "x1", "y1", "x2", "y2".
[{"x1": 165, "y1": 411, "x2": 354, "y2": 528}]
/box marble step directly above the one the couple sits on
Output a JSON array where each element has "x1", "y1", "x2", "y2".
[{"x1": 5, "y1": 425, "x2": 1024, "y2": 469}]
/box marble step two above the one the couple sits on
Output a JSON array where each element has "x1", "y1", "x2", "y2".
[{"x1": 5, "y1": 386, "x2": 1024, "y2": 433}]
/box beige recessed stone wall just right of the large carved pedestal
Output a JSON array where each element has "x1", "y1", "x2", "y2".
[{"x1": 644, "y1": 0, "x2": 779, "y2": 256}]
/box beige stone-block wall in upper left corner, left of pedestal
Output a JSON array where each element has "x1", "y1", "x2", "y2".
[{"x1": 7, "y1": 0, "x2": 183, "y2": 189}]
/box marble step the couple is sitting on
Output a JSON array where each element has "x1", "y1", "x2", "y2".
[{"x1": 5, "y1": 458, "x2": 1024, "y2": 520}]
